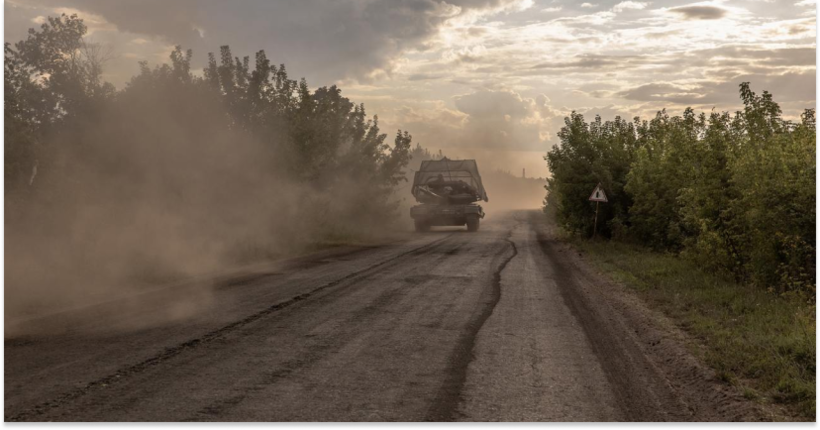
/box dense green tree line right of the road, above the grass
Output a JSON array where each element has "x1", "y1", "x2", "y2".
[{"x1": 545, "y1": 82, "x2": 817, "y2": 297}]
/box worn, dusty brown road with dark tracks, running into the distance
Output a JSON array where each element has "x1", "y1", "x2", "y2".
[{"x1": 4, "y1": 211, "x2": 749, "y2": 421}]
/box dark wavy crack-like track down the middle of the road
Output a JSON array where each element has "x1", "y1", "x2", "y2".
[{"x1": 425, "y1": 218, "x2": 521, "y2": 422}]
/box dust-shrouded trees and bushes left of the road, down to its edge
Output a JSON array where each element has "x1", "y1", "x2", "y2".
[{"x1": 3, "y1": 15, "x2": 426, "y2": 308}]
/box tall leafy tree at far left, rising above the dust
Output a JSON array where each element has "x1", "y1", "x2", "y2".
[{"x1": 3, "y1": 14, "x2": 114, "y2": 193}]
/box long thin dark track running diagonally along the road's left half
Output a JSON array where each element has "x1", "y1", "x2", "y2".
[{"x1": 9, "y1": 233, "x2": 453, "y2": 422}]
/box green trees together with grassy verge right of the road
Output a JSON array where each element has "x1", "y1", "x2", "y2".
[{"x1": 545, "y1": 83, "x2": 817, "y2": 417}]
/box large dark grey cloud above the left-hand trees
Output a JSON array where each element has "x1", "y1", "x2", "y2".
[{"x1": 22, "y1": 0, "x2": 532, "y2": 85}]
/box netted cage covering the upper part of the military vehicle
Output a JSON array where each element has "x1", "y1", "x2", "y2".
[{"x1": 412, "y1": 157, "x2": 489, "y2": 204}]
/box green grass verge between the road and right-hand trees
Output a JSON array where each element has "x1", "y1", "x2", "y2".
[{"x1": 570, "y1": 239, "x2": 817, "y2": 421}]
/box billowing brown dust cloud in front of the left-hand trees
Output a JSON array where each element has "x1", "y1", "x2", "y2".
[{"x1": 4, "y1": 77, "x2": 398, "y2": 336}]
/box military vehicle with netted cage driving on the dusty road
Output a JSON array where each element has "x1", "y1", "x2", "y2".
[{"x1": 410, "y1": 157, "x2": 489, "y2": 231}]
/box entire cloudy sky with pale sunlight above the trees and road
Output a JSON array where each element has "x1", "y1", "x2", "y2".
[{"x1": 3, "y1": 0, "x2": 817, "y2": 177}]
